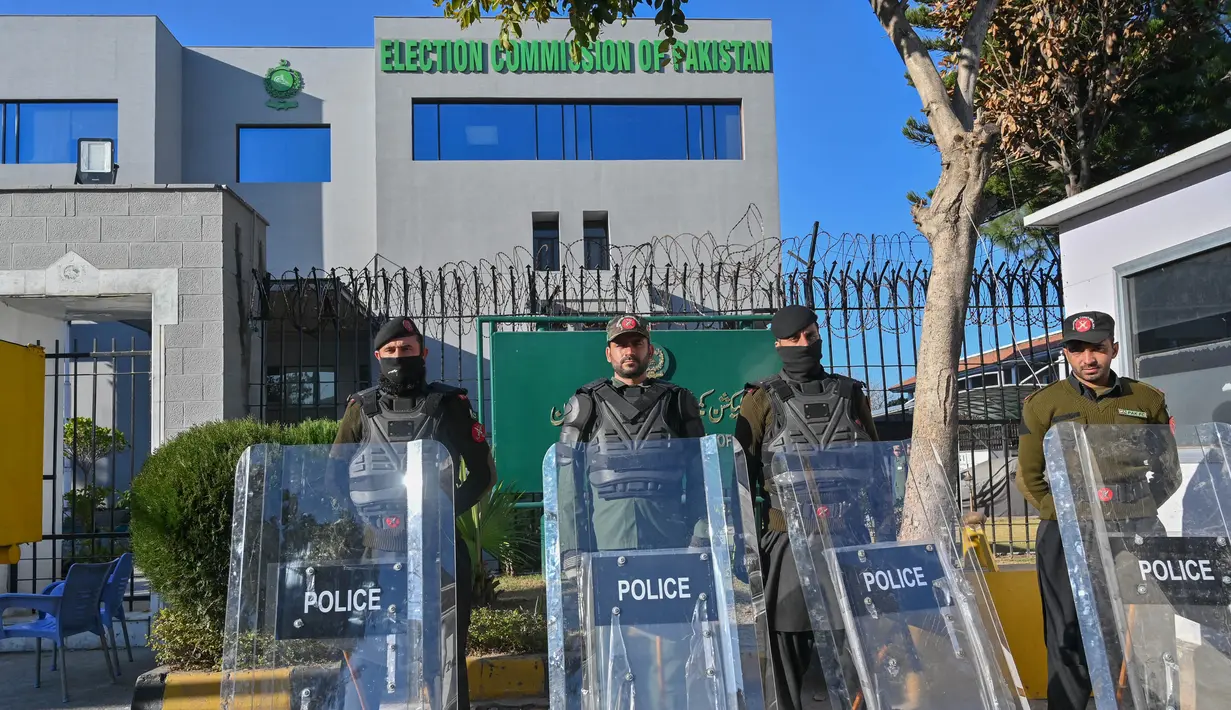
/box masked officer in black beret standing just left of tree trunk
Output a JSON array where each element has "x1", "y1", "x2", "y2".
[{"x1": 735, "y1": 305, "x2": 878, "y2": 710}]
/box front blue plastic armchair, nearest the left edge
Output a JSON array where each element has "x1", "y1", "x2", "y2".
[{"x1": 0, "y1": 562, "x2": 116, "y2": 703}]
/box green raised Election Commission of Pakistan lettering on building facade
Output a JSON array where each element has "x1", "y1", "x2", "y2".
[{"x1": 377, "y1": 39, "x2": 773, "y2": 74}]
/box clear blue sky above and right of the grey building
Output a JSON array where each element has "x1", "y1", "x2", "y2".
[{"x1": 0, "y1": 0, "x2": 939, "y2": 236}]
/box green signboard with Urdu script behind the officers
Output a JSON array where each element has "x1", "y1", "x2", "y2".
[{"x1": 487, "y1": 329, "x2": 782, "y2": 493}]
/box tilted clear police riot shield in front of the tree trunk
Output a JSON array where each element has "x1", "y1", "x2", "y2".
[{"x1": 772, "y1": 442, "x2": 1028, "y2": 710}]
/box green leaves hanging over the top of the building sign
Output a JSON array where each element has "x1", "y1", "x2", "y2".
[{"x1": 432, "y1": 0, "x2": 688, "y2": 59}]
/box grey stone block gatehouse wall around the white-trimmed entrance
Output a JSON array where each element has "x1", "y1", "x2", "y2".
[{"x1": 0, "y1": 185, "x2": 267, "y2": 445}]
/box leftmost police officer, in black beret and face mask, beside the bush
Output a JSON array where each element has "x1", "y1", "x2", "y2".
[{"x1": 334, "y1": 317, "x2": 496, "y2": 710}]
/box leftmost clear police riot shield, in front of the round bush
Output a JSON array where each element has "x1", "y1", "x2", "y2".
[{"x1": 222, "y1": 441, "x2": 465, "y2": 710}]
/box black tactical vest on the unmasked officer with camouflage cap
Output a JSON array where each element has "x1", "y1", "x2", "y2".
[{"x1": 577, "y1": 379, "x2": 687, "y2": 500}]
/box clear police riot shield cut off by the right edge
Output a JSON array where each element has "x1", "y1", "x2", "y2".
[{"x1": 1044, "y1": 420, "x2": 1231, "y2": 710}]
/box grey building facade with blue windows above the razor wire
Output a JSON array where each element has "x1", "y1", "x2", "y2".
[{"x1": 0, "y1": 16, "x2": 779, "y2": 274}]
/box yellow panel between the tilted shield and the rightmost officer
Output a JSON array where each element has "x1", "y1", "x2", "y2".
[{"x1": 984, "y1": 566, "x2": 1048, "y2": 699}]
